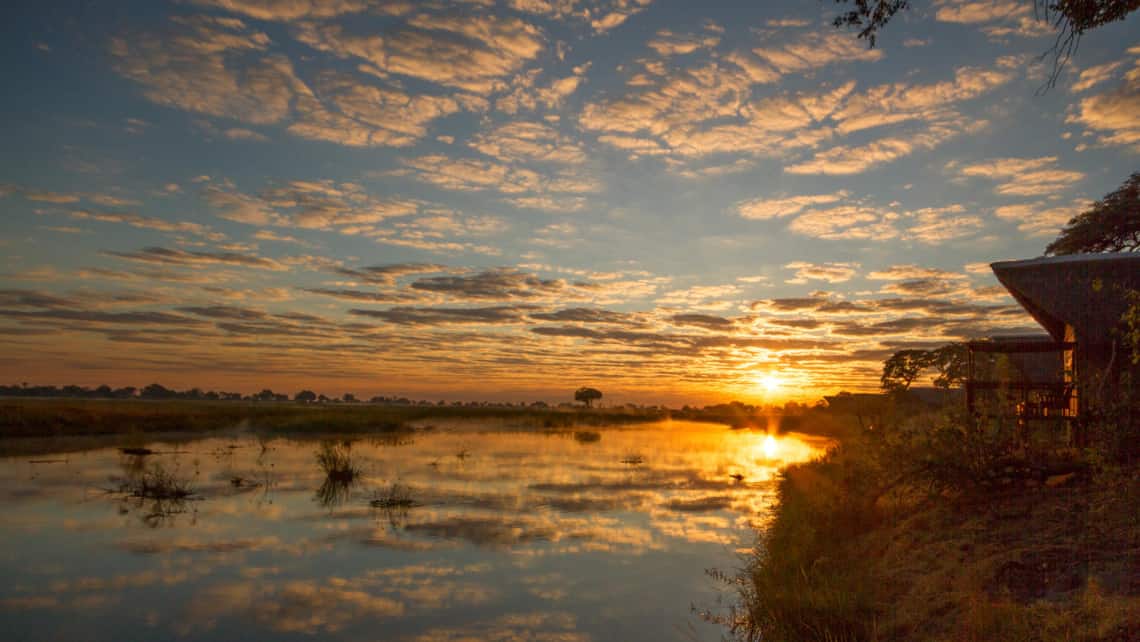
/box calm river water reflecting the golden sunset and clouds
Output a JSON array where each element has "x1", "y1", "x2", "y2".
[{"x1": 0, "y1": 422, "x2": 819, "y2": 642}]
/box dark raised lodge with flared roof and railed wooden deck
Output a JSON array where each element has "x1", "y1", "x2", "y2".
[{"x1": 967, "y1": 252, "x2": 1140, "y2": 431}]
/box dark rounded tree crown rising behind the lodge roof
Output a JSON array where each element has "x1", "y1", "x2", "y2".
[{"x1": 1045, "y1": 172, "x2": 1140, "y2": 254}]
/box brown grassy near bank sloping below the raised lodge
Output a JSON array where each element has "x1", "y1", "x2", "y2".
[{"x1": 726, "y1": 416, "x2": 1140, "y2": 641}]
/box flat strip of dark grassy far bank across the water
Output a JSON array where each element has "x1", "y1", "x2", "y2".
[{"x1": 0, "y1": 399, "x2": 661, "y2": 437}]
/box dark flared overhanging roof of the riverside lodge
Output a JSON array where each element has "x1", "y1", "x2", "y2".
[{"x1": 990, "y1": 252, "x2": 1140, "y2": 342}]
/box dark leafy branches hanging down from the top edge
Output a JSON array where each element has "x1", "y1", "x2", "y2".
[{"x1": 833, "y1": 0, "x2": 1140, "y2": 87}]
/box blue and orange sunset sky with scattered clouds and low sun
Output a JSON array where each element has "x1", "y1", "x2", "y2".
[{"x1": 0, "y1": 0, "x2": 1140, "y2": 404}]
